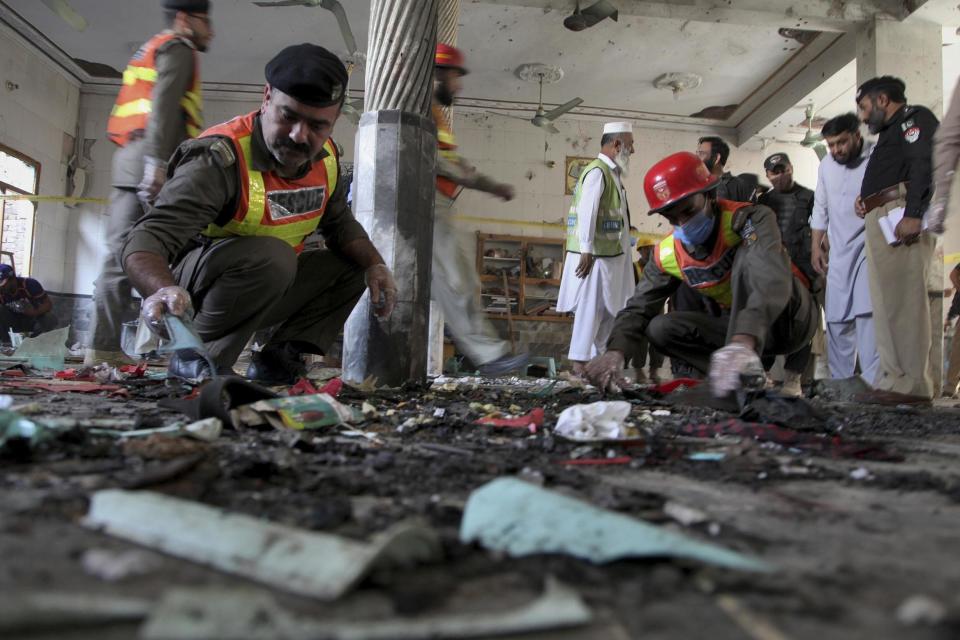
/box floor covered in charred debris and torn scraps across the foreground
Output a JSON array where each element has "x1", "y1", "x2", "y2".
[{"x1": 0, "y1": 365, "x2": 960, "y2": 639}]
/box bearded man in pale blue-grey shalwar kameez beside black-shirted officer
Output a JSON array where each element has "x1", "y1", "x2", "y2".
[{"x1": 810, "y1": 113, "x2": 880, "y2": 384}]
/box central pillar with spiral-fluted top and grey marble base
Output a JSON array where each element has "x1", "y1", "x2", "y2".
[{"x1": 343, "y1": 0, "x2": 438, "y2": 386}]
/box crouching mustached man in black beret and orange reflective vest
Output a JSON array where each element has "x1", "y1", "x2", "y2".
[{"x1": 123, "y1": 44, "x2": 397, "y2": 384}]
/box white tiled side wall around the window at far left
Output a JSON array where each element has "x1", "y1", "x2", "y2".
[{"x1": 0, "y1": 26, "x2": 80, "y2": 291}]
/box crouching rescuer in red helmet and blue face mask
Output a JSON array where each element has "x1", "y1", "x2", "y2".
[{"x1": 586, "y1": 152, "x2": 820, "y2": 397}]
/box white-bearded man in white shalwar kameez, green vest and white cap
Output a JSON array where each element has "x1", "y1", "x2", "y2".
[{"x1": 557, "y1": 122, "x2": 634, "y2": 375}]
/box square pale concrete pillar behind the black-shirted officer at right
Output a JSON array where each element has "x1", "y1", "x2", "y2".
[{"x1": 857, "y1": 17, "x2": 948, "y2": 397}]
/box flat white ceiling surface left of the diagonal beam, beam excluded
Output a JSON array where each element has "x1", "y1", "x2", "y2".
[{"x1": 5, "y1": 0, "x2": 824, "y2": 116}]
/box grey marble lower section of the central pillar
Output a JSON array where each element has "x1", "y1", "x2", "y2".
[{"x1": 343, "y1": 110, "x2": 437, "y2": 386}]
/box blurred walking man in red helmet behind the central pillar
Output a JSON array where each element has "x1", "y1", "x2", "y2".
[{"x1": 430, "y1": 43, "x2": 529, "y2": 376}]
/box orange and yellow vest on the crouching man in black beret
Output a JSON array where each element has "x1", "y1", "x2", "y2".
[{"x1": 201, "y1": 111, "x2": 339, "y2": 253}]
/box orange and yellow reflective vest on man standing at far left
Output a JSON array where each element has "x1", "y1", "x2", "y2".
[{"x1": 107, "y1": 31, "x2": 203, "y2": 147}]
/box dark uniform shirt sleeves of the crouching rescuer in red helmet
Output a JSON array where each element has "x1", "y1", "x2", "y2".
[{"x1": 607, "y1": 205, "x2": 803, "y2": 353}]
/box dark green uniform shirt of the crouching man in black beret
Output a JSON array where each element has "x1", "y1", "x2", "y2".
[{"x1": 120, "y1": 117, "x2": 369, "y2": 264}]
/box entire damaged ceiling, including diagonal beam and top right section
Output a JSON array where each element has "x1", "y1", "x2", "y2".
[{"x1": 0, "y1": 0, "x2": 960, "y2": 142}]
